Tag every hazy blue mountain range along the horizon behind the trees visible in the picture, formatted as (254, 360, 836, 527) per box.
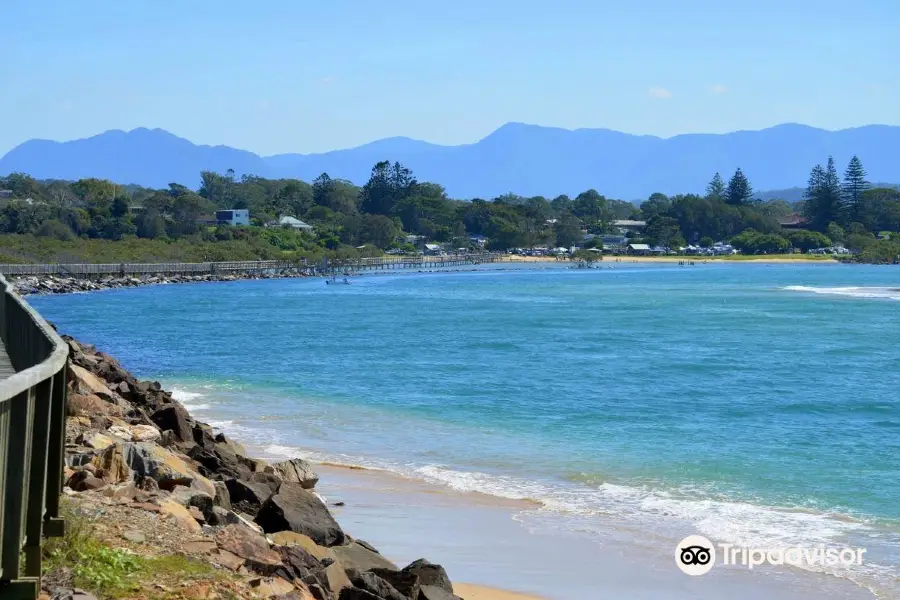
(0, 123, 900, 200)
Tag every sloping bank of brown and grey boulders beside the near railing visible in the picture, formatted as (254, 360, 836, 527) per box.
(53, 336, 468, 600)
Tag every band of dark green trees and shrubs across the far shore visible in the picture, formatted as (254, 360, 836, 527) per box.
(0, 157, 900, 262)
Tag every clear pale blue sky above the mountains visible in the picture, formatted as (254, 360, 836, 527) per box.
(0, 0, 900, 155)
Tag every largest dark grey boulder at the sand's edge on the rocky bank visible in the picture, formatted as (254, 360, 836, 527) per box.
(256, 483, 346, 547)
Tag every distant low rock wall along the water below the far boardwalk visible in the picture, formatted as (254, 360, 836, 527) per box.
(7, 269, 315, 296)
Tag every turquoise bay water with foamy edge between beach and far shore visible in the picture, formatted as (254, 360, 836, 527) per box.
(30, 263, 900, 597)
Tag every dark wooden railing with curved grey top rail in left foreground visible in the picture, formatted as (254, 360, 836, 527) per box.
(0, 276, 68, 600)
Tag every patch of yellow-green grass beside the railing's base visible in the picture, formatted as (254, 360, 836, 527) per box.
(43, 503, 230, 600)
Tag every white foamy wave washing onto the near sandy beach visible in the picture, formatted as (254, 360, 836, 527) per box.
(256, 445, 900, 590)
